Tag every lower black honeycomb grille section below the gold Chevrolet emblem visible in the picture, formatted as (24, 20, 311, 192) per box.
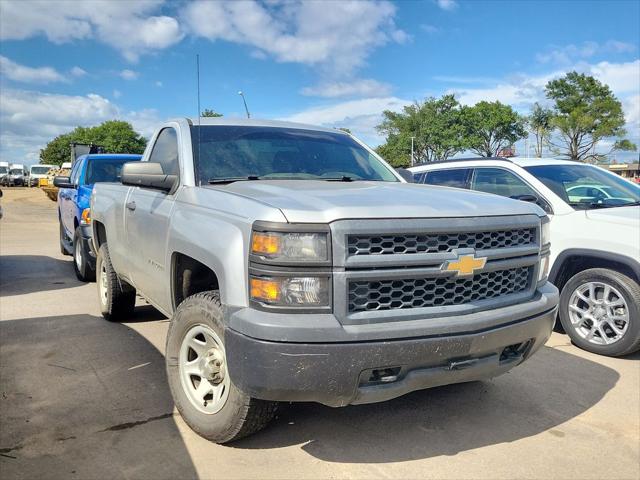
(349, 267, 532, 313)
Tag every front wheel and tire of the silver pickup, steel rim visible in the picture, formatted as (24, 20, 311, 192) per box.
(165, 291, 277, 444)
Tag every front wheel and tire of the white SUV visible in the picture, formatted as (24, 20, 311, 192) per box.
(560, 268, 640, 357)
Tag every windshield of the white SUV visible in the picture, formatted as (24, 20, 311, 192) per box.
(525, 164, 640, 210)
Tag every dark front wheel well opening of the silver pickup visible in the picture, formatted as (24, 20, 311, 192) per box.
(172, 253, 220, 308)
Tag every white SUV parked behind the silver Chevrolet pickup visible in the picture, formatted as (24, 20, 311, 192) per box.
(410, 158, 640, 356)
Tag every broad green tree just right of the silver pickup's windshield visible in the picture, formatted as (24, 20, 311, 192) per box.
(377, 95, 467, 166)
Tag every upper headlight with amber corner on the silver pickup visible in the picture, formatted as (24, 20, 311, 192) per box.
(251, 231, 329, 263)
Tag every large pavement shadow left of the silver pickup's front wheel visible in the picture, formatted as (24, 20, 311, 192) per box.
(0, 314, 197, 479)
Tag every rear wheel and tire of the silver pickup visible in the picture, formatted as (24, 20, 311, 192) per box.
(96, 243, 136, 322)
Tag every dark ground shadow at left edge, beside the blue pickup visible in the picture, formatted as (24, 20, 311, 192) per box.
(0, 255, 84, 297)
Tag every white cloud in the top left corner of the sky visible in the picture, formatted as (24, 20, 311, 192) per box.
(0, 0, 183, 61)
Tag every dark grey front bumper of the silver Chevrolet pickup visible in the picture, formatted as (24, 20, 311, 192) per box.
(225, 287, 558, 407)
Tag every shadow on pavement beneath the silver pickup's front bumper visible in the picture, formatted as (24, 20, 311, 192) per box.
(233, 347, 619, 463)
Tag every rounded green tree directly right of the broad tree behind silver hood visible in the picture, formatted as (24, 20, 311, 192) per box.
(462, 101, 527, 157)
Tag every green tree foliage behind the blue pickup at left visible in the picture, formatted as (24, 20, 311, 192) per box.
(40, 120, 147, 165)
